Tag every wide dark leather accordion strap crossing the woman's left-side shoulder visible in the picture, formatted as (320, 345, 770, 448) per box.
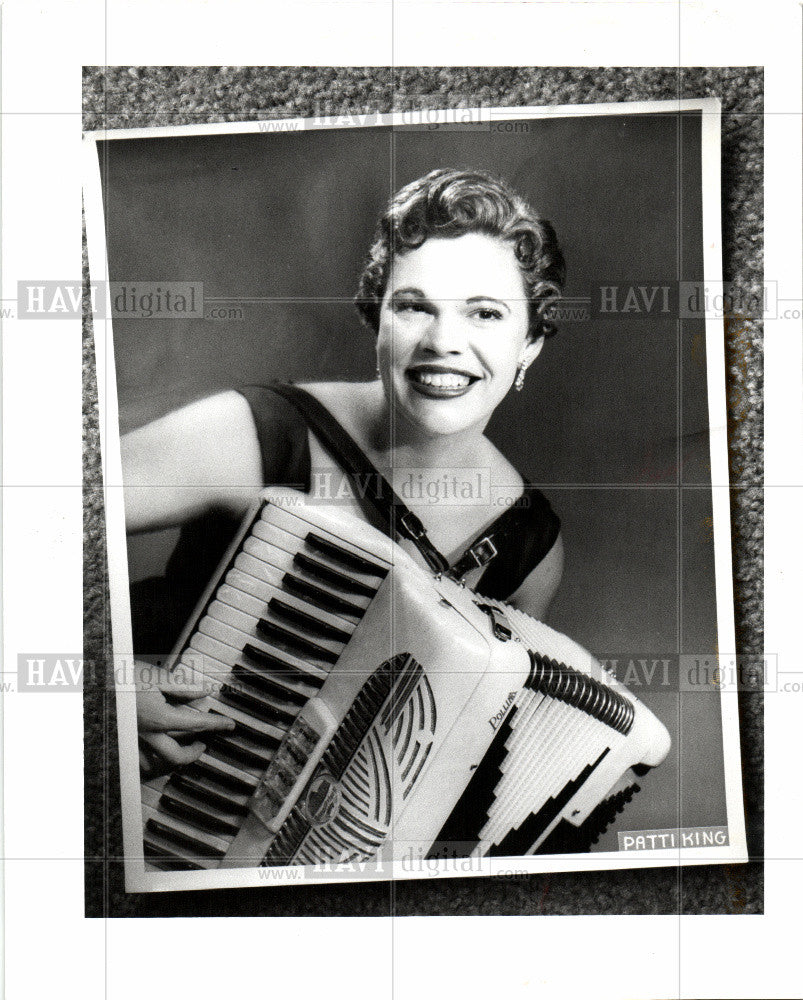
(272, 382, 449, 573)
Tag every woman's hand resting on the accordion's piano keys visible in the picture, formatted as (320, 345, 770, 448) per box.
(134, 663, 234, 777)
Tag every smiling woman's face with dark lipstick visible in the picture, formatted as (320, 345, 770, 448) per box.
(377, 233, 543, 437)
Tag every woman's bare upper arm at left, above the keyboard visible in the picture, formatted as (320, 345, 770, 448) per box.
(121, 391, 262, 532)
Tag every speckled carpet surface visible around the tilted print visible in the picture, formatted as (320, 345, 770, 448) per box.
(83, 67, 763, 916)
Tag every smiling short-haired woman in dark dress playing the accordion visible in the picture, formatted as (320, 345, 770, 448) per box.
(122, 169, 564, 764)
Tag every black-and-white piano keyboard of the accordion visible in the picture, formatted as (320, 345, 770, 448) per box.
(143, 504, 398, 869)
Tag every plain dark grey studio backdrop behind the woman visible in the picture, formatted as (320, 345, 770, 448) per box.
(100, 107, 725, 849)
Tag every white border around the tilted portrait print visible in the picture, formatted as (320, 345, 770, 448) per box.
(84, 98, 748, 892)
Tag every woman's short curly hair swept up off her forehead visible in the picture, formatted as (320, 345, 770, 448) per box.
(354, 168, 566, 340)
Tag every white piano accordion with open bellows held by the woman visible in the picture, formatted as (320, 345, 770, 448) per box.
(142, 489, 670, 870)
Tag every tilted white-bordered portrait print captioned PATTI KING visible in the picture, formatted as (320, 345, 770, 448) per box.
(85, 98, 747, 904)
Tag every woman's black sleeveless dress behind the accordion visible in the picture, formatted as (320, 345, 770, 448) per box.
(131, 385, 560, 658)
